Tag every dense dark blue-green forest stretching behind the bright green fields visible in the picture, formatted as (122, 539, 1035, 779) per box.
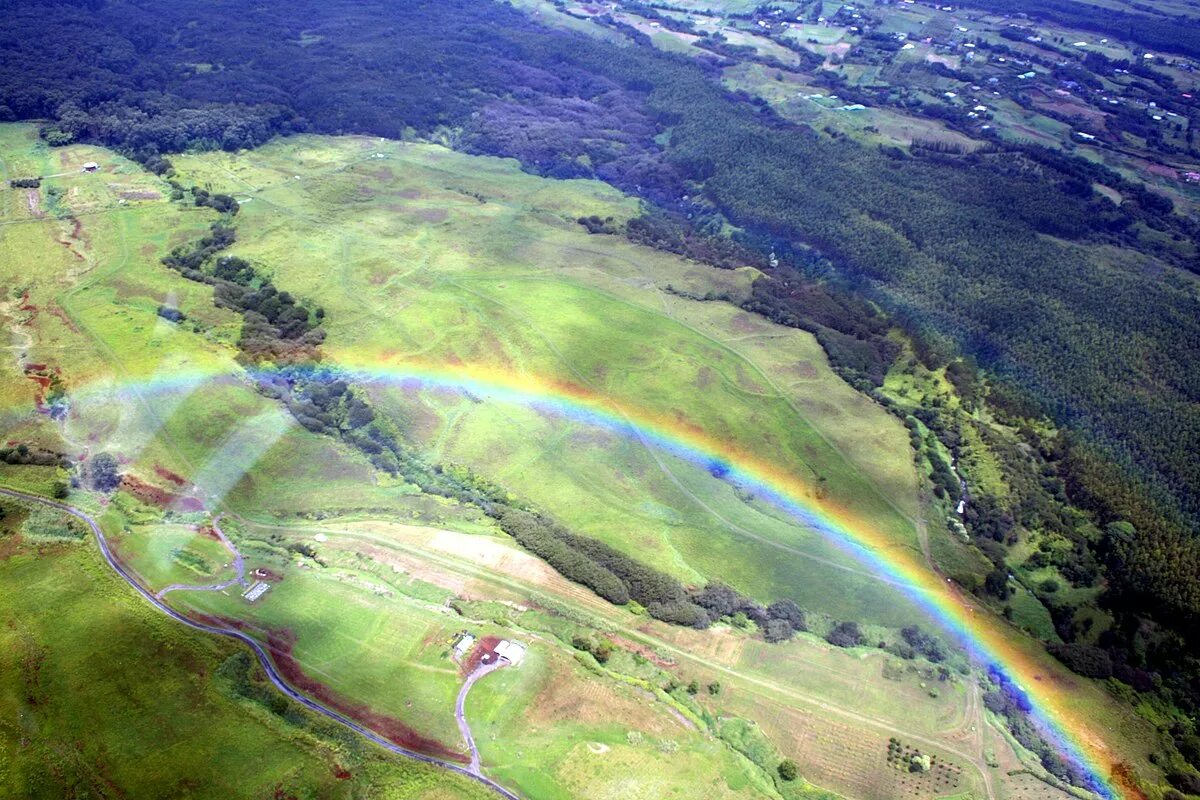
(7, 0, 1200, 762)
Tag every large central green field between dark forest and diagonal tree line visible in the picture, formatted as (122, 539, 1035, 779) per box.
(171, 138, 917, 624)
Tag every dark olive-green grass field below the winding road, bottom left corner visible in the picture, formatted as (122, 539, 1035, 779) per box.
(0, 503, 491, 800)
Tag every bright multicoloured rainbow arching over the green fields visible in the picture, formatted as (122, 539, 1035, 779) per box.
(42, 353, 1140, 800)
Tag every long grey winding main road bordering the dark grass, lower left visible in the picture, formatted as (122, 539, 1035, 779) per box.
(0, 487, 521, 800)
